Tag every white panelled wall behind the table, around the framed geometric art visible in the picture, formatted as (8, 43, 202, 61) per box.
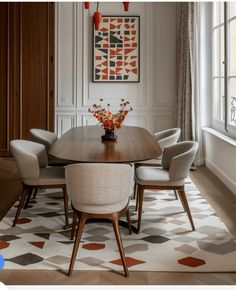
(55, 2, 176, 136)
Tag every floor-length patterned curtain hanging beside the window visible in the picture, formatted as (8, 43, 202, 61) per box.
(176, 2, 203, 165)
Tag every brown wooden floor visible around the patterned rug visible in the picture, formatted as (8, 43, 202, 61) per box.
(0, 158, 236, 285)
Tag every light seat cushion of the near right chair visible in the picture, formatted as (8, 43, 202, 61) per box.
(135, 167, 184, 186)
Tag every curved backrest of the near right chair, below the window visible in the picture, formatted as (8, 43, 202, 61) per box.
(162, 141, 198, 180)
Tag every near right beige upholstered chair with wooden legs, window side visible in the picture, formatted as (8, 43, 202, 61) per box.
(135, 141, 198, 231)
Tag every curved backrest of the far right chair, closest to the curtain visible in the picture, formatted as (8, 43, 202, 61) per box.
(153, 128, 181, 150)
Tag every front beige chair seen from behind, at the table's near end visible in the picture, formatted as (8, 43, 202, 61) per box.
(66, 163, 134, 276)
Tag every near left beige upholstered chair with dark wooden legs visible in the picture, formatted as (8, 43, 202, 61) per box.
(10, 140, 68, 226)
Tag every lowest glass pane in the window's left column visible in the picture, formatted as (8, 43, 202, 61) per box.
(213, 78, 225, 121)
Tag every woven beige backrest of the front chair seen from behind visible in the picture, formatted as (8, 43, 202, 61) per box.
(65, 163, 134, 205)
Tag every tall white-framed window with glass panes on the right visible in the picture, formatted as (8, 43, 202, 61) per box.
(213, 2, 236, 137)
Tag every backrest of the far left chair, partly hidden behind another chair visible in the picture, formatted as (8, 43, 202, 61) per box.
(30, 129, 58, 153)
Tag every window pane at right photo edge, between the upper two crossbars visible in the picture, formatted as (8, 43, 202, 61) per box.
(229, 19, 236, 75)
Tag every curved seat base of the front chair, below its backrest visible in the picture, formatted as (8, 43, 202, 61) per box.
(72, 198, 129, 214)
